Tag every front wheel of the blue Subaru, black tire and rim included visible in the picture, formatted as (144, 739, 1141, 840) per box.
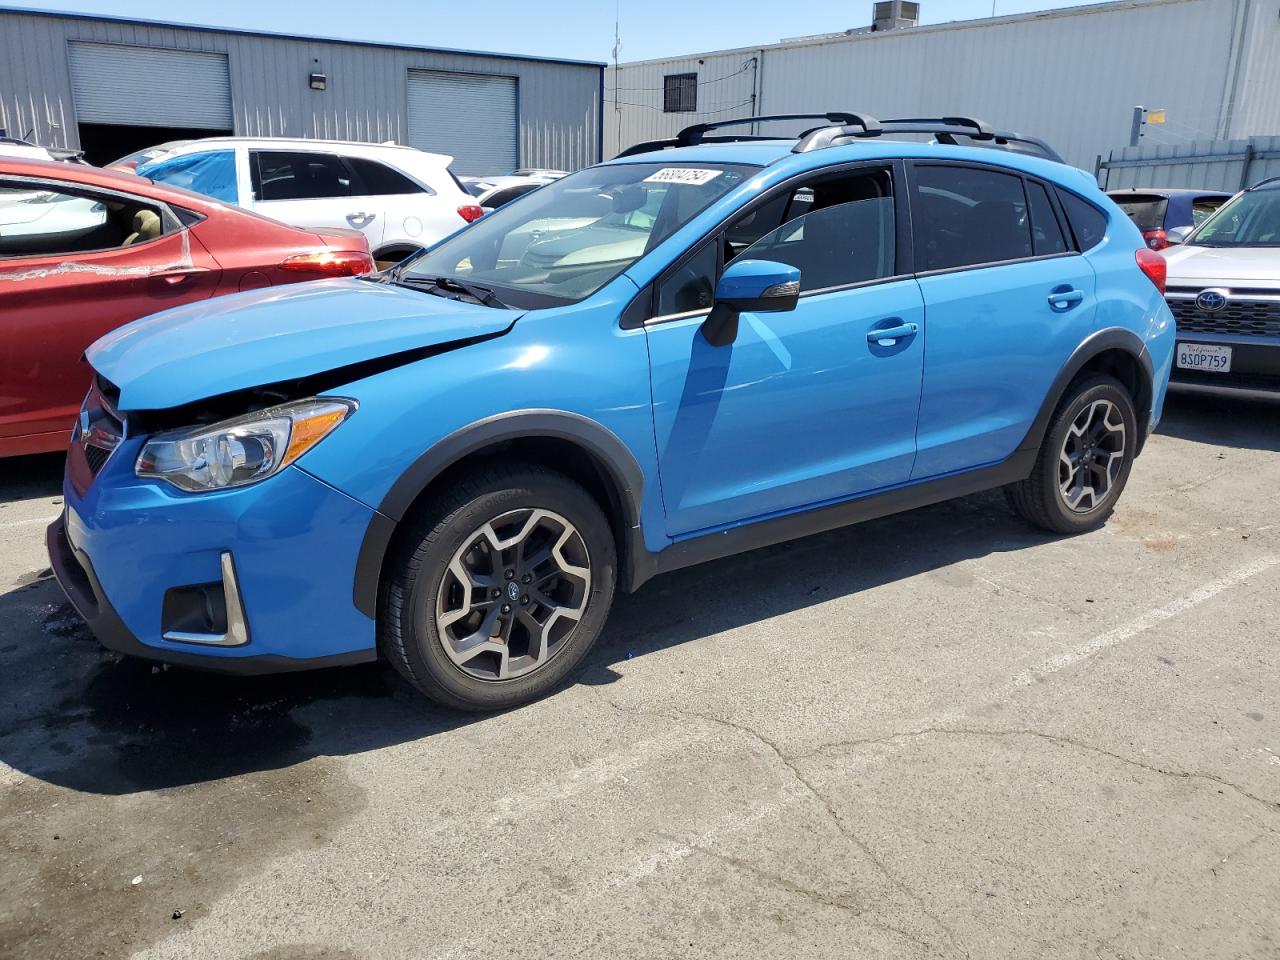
(379, 463, 617, 710)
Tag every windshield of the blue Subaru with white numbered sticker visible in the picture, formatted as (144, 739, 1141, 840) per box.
(393, 163, 756, 308)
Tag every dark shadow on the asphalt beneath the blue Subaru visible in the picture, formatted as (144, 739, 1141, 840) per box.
(0, 493, 1048, 795)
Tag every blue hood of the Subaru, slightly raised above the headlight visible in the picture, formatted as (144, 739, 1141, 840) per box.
(86, 279, 520, 410)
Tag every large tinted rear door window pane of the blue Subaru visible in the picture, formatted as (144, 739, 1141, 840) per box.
(911, 165, 1032, 270)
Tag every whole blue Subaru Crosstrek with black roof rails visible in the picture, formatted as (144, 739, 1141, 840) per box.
(47, 114, 1175, 709)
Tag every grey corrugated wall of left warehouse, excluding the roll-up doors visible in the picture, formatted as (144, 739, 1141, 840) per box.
(0, 10, 600, 170)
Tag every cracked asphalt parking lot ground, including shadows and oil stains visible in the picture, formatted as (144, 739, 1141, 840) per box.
(0, 394, 1280, 960)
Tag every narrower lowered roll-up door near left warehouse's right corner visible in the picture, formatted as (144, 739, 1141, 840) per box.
(408, 70, 520, 175)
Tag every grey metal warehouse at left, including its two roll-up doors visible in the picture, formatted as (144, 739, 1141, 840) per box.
(0, 10, 604, 174)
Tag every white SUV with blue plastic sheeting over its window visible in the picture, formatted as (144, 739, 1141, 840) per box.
(136, 137, 483, 264)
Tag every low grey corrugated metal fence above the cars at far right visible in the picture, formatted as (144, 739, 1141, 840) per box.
(1098, 137, 1280, 193)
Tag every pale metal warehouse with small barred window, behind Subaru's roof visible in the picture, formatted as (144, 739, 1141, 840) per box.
(605, 0, 1280, 169)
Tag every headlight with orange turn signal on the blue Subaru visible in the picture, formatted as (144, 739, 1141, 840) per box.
(134, 397, 356, 492)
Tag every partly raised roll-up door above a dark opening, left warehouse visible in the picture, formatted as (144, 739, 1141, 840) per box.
(68, 41, 233, 131)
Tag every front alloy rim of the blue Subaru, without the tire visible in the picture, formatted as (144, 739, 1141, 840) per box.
(435, 508, 591, 681)
